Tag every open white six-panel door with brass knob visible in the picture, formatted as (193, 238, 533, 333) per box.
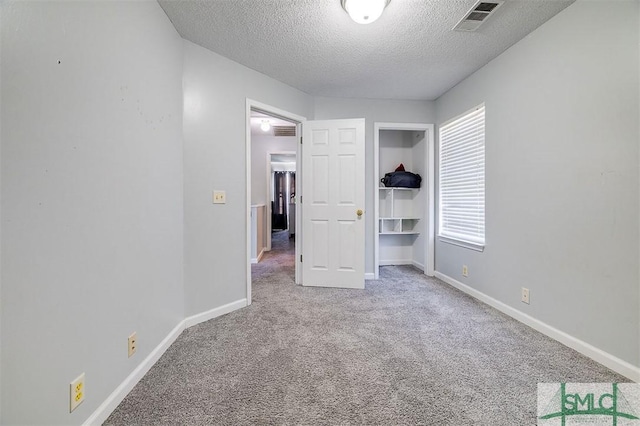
(302, 118, 365, 288)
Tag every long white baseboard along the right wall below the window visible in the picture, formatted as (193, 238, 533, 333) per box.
(435, 271, 640, 382)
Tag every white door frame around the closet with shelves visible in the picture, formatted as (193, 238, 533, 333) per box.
(373, 122, 436, 279)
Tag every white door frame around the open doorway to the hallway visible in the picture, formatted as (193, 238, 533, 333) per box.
(245, 98, 307, 305)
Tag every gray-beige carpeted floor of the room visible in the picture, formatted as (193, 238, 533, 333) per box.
(105, 234, 628, 426)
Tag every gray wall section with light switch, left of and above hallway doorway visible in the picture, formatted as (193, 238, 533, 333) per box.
(183, 41, 313, 315)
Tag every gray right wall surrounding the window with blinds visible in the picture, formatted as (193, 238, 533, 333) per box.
(436, 1, 640, 365)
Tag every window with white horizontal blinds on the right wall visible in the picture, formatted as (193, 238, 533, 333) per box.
(438, 104, 485, 250)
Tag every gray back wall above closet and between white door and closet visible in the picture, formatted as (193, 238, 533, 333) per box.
(314, 97, 436, 274)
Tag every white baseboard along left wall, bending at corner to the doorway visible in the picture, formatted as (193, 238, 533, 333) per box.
(83, 299, 247, 426)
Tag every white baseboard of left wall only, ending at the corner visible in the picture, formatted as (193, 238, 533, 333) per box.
(84, 320, 185, 425)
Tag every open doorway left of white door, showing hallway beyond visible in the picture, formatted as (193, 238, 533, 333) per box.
(246, 99, 305, 304)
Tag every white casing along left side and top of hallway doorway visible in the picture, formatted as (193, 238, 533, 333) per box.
(245, 98, 307, 305)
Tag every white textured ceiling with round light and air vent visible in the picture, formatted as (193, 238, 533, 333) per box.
(159, 0, 574, 100)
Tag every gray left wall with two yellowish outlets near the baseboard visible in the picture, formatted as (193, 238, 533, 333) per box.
(1, 1, 184, 425)
